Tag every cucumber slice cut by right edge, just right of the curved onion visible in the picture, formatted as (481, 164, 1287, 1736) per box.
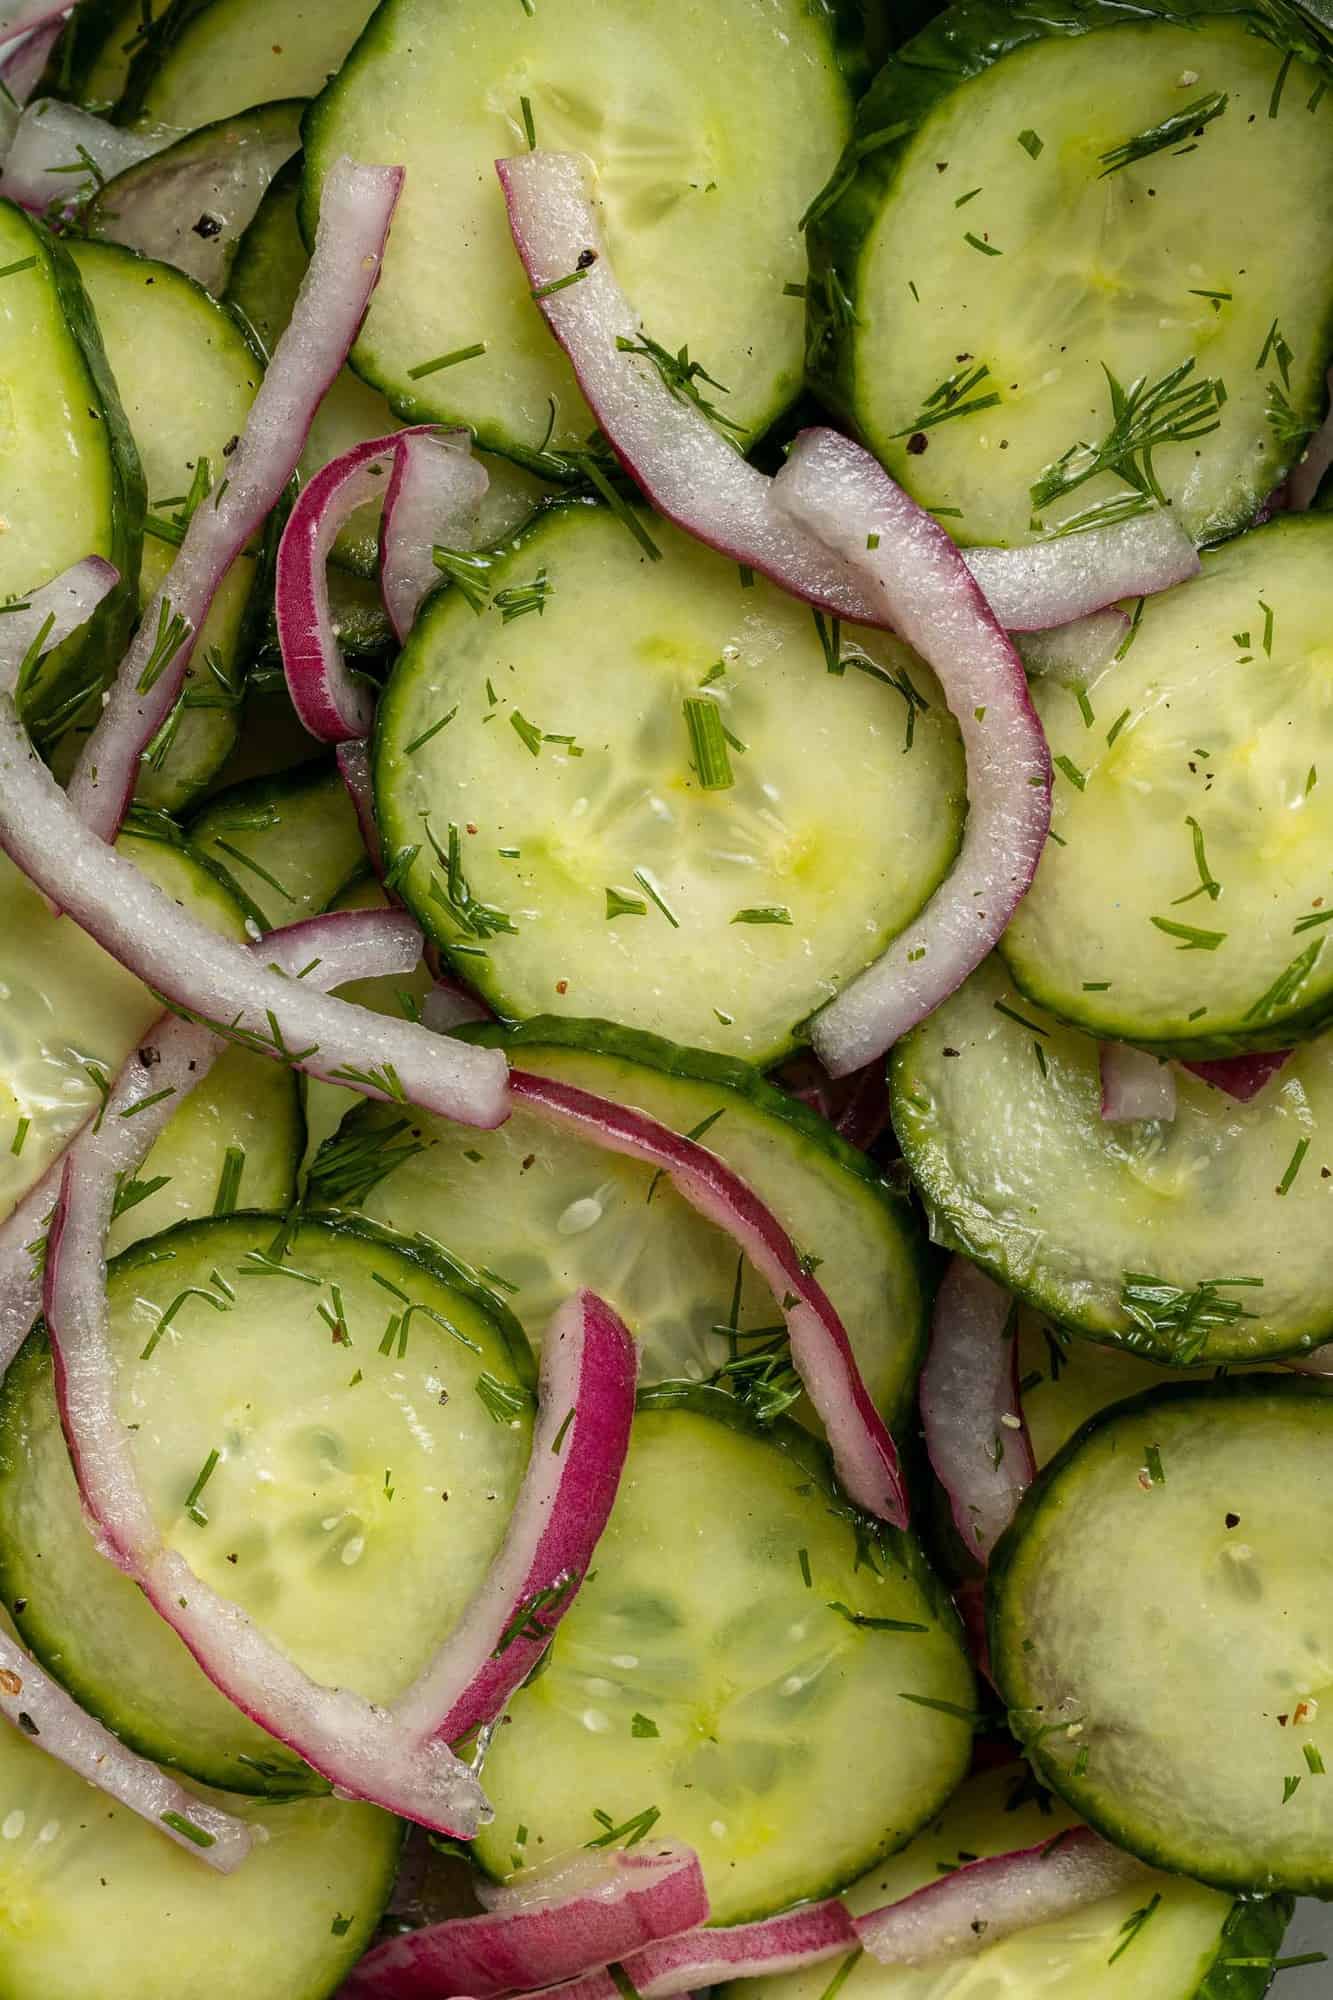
(1001, 514, 1333, 1056)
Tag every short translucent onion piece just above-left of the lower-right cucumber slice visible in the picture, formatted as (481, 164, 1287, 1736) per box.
(921, 1256, 1037, 1566)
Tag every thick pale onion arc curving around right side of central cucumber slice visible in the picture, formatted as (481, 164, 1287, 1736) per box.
(768, 428, 1051, 1076)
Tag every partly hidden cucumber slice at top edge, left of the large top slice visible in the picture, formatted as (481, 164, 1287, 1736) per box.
(120, 0, 374, 132)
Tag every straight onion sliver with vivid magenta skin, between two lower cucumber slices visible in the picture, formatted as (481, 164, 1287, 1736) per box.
(394, 1292, 638, 1744)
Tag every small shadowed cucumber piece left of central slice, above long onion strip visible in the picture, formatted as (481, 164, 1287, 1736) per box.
(190, 762, 366, 930)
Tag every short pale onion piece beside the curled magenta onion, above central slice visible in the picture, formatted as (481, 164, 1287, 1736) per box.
(380, 430, 490, 644)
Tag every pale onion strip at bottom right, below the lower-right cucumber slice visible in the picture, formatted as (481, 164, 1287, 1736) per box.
(855, 1826, 1147, 1966)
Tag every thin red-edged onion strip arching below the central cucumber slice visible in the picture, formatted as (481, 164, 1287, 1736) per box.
(510, 1070, 907, 1528)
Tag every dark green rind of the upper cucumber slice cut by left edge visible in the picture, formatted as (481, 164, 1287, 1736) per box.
(2, 202, 148, 748)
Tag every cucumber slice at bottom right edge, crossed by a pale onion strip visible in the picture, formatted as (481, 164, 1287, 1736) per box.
(719, 1766, 1291, 2000)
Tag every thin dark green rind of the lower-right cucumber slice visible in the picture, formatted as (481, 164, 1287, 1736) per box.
(987, 1374, 1333, 1888)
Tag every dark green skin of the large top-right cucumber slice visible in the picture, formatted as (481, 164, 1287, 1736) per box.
(805, 0, 1333, 544)
